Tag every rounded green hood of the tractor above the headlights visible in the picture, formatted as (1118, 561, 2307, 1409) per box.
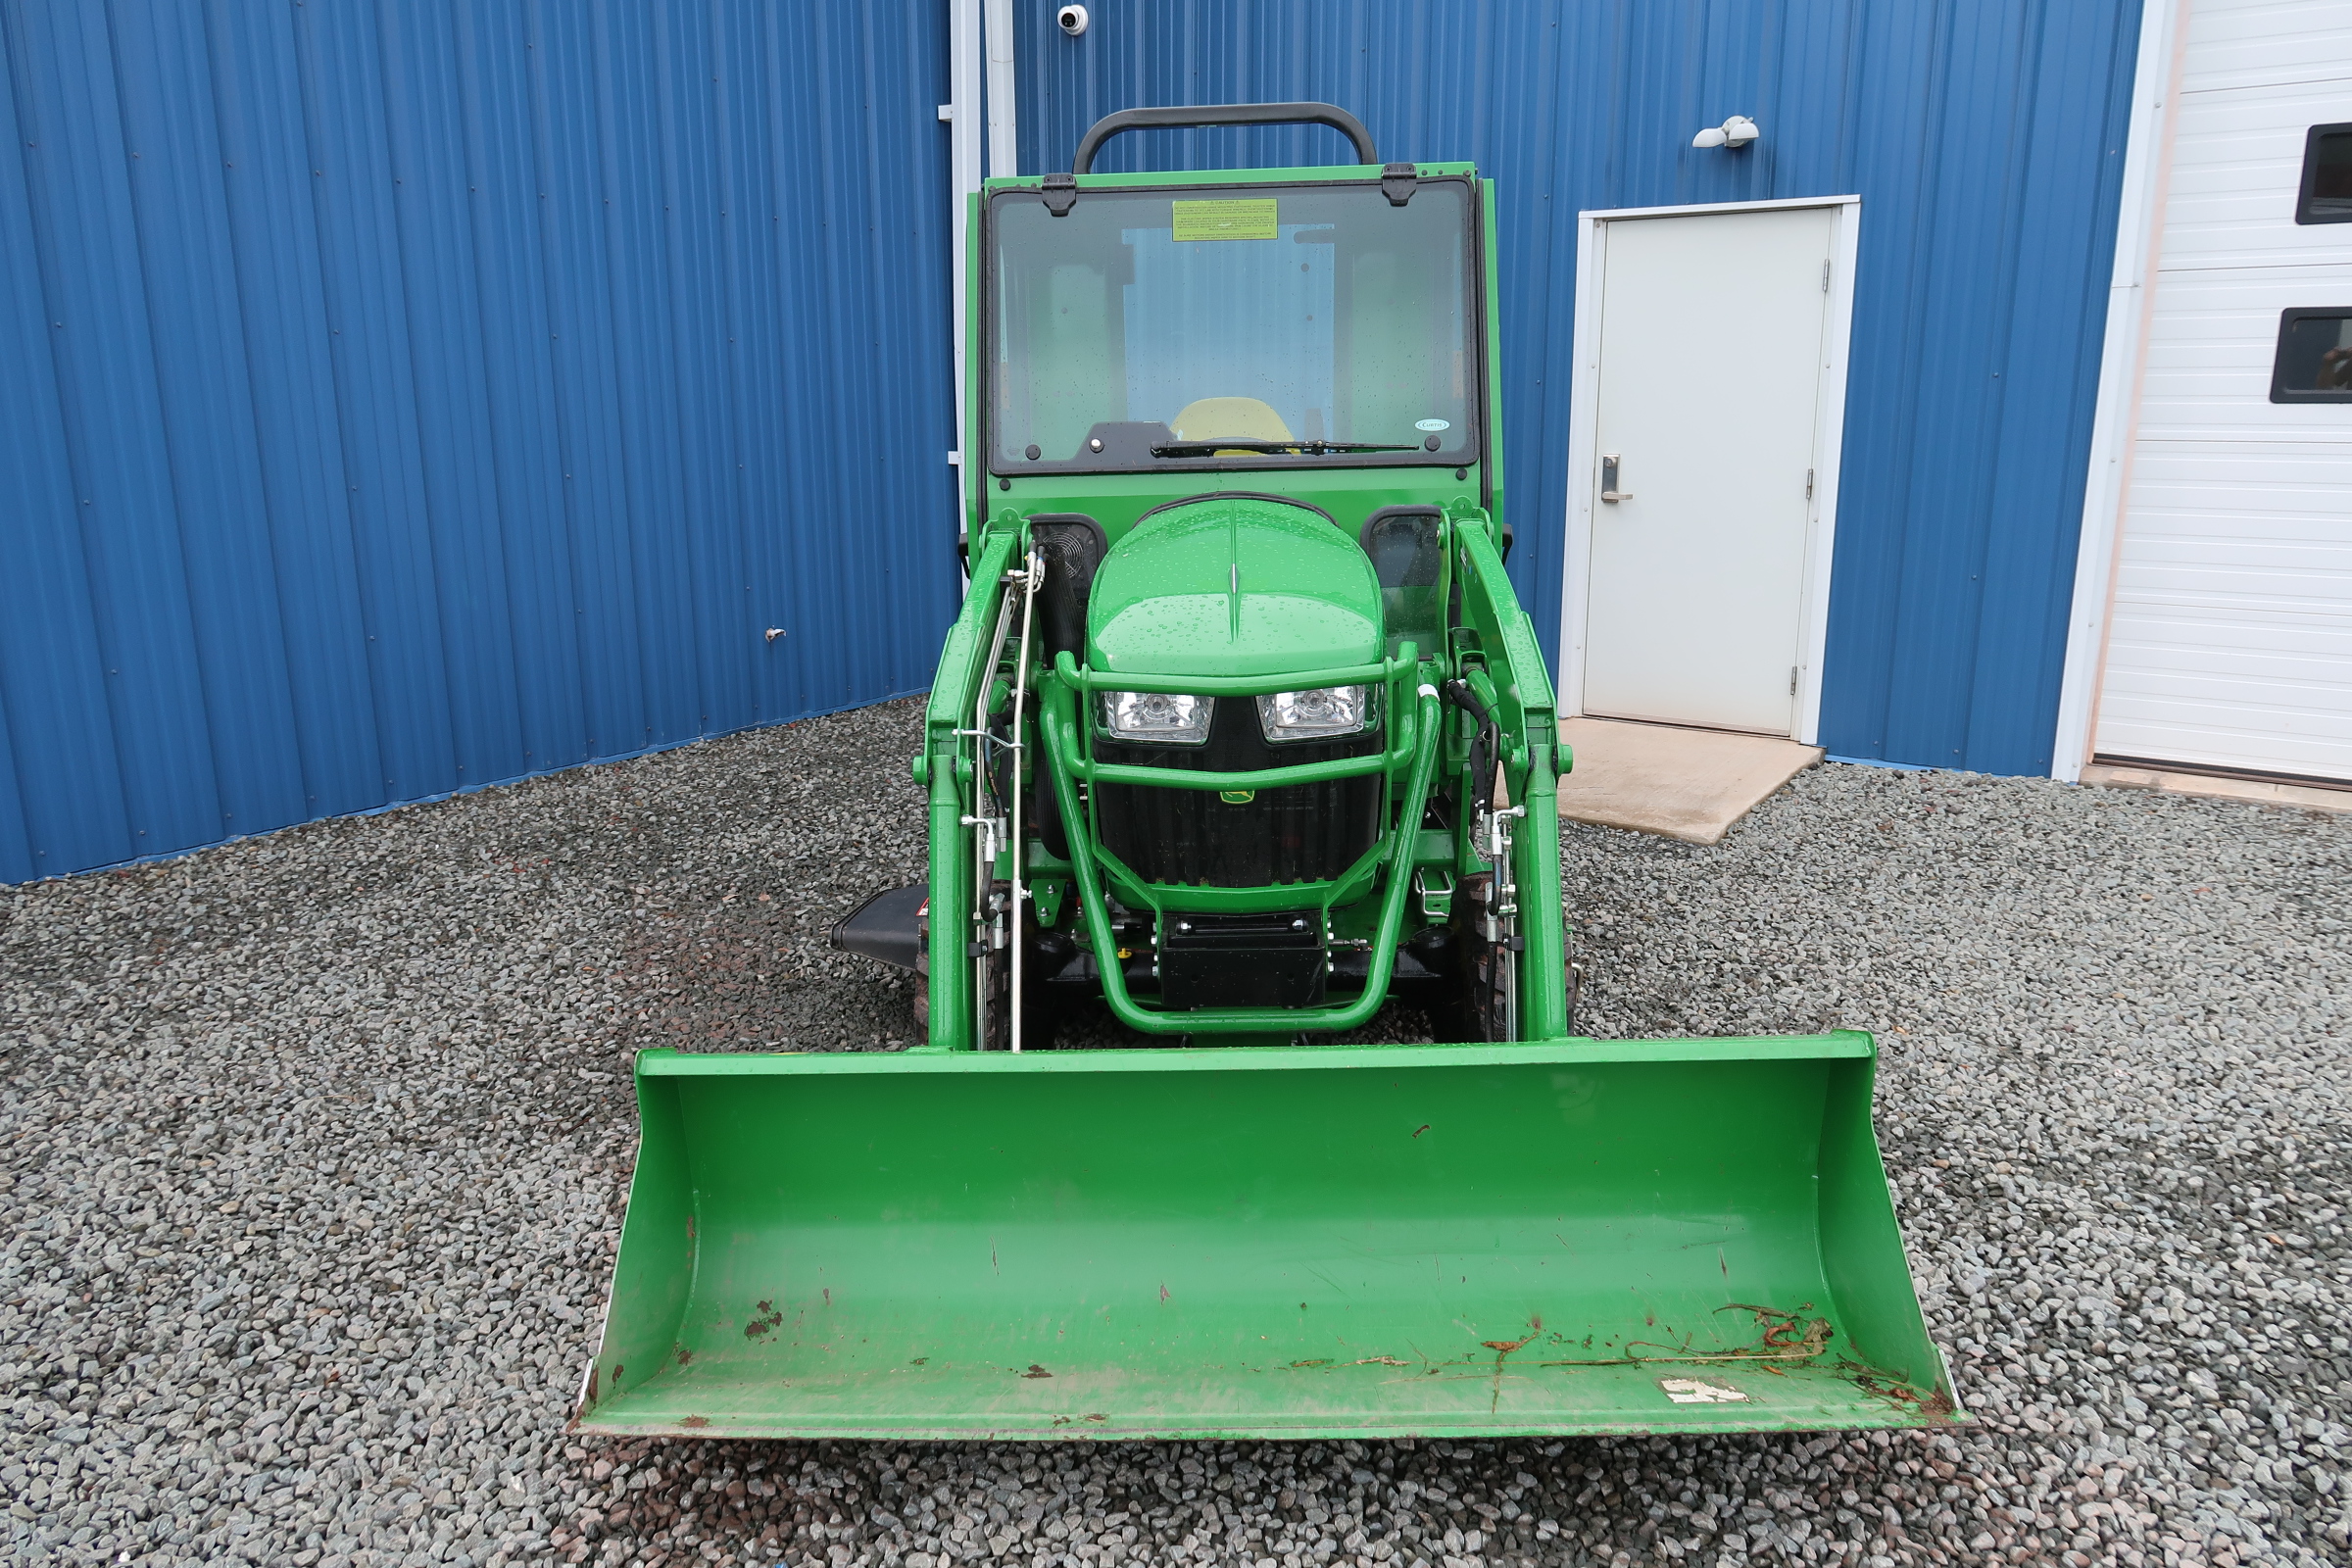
(1087, 496, 1383, 674)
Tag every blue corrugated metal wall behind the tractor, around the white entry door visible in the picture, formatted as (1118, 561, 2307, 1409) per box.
(1018, 0, 2138, 773)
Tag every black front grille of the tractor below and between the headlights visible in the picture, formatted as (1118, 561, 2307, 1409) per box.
(1094, 696, 1388, 886)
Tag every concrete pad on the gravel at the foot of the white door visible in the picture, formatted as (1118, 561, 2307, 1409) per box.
(1559, 719, 1821, 844)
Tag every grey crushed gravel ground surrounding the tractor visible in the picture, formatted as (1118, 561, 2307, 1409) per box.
(0, 703, 2352, 1568)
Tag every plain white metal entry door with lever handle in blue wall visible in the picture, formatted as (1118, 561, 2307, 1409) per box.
(1583, 207, 1835, 736)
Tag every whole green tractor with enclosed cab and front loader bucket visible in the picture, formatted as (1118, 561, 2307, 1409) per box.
(576, 104, 1962, 1439)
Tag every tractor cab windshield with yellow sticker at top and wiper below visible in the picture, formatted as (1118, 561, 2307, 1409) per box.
(990, 178, 1477, 472)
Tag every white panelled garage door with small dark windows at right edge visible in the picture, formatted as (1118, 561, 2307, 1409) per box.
(2095, 0, 2352, 780)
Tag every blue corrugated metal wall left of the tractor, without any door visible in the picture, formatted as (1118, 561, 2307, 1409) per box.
(0, 0, 959, 882)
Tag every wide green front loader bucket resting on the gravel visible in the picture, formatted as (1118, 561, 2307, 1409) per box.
(578, 1034, 1962, 1439)
